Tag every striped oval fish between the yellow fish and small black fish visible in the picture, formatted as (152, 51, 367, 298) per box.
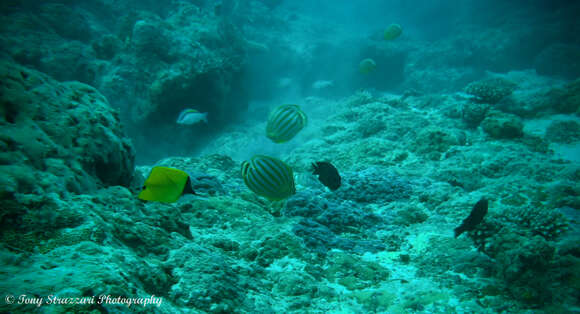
(242, 155, 296, 201)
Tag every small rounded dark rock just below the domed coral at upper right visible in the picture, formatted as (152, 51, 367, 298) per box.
(481, 111, 524, 139)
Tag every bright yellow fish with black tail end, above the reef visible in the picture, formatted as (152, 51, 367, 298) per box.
(138, 167, 195, 203)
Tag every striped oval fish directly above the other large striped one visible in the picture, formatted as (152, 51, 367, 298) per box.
(266, 105, 308, 143)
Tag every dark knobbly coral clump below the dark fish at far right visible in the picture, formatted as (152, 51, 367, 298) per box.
(468, 207, 567, 304)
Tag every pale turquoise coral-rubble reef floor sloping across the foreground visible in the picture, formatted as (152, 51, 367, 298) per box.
(0, 76, 579, 312)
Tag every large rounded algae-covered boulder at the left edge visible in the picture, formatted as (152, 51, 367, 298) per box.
(0, 62, 135, 197)
